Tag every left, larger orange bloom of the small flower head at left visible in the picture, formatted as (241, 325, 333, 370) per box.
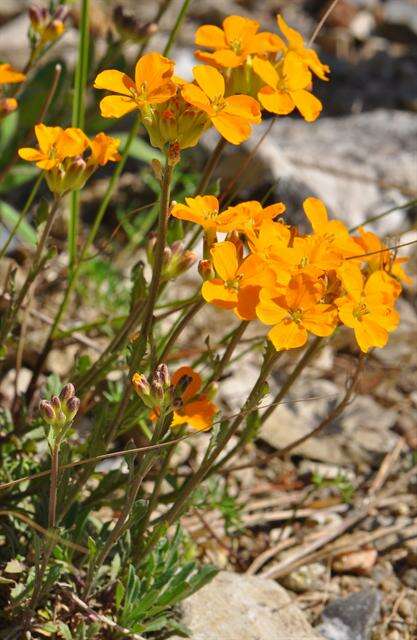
(19, 124, 89, 171)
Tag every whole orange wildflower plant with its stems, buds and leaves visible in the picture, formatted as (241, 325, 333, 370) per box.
(0, 0, 409, 638)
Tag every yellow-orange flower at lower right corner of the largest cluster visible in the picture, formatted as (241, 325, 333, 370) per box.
(335, 263, 399, 353)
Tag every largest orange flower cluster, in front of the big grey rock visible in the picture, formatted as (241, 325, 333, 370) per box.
(171, 196, 409, 352)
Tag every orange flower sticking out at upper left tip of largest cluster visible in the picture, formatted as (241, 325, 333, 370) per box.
(171, 196, 236, 232)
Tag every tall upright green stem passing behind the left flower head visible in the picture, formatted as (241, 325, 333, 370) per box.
(68, 0, 90, 280)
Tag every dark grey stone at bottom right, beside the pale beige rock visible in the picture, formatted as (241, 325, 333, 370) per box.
(318, 589, 381, 640)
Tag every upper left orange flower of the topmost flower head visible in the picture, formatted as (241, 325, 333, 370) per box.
(195, 16, 285, 68)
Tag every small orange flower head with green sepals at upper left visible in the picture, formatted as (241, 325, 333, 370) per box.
(19, 124, 120, 195)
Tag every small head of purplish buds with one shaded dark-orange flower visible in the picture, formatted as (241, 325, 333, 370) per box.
(132, 364, 218, 431)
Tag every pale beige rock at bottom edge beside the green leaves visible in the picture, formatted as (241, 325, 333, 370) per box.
(172, 571, 320, 640)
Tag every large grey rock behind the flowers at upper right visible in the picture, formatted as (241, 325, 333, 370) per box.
(234, 109, 417, 234)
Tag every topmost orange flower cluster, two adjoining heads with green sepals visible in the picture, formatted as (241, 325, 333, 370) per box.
(94, 16, 329, 149)
